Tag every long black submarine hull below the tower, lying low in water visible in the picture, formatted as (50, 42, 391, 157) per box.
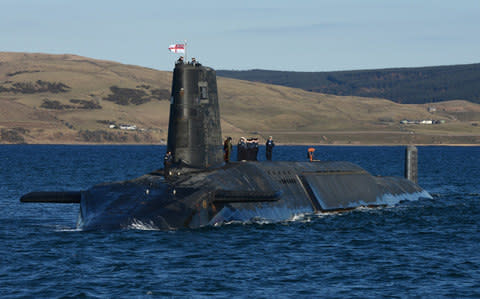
(78, 162, 430, 230)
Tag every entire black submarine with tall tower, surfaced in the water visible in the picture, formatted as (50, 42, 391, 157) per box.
(20, 61, 431, 230)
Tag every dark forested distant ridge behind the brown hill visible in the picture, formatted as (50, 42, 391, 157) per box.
(218, 64, 480, 104)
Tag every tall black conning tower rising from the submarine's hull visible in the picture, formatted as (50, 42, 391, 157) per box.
(167, 63, 223, 168)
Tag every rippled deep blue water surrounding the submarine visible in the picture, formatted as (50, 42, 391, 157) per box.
(0, 145, 480, 298)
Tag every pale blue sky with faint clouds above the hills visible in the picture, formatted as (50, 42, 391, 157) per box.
(0, 0, 480, 71)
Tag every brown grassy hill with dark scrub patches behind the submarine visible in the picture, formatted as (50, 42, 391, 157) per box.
(0, 53, 480, 144)
